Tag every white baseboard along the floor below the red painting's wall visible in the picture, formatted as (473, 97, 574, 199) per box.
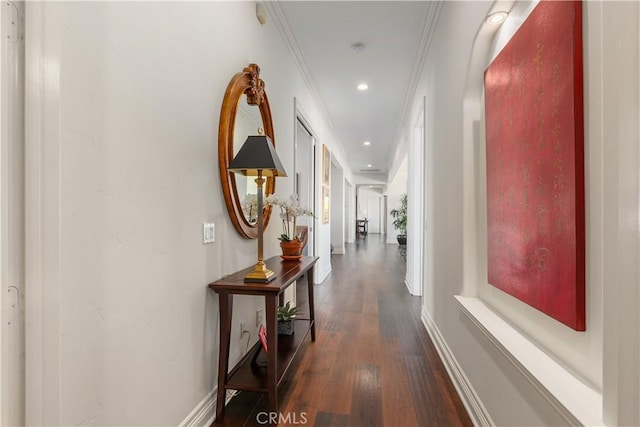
(421, 307, 495, 426)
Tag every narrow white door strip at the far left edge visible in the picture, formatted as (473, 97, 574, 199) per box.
(0, 1, 25, 426)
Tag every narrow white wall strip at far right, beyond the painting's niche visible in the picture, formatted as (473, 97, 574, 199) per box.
(600, 2, 640, 425)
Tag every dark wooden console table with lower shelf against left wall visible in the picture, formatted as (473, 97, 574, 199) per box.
(209, 256, 318, 422)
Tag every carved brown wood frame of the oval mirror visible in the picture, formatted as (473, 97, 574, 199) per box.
(218, 64, 276, 239)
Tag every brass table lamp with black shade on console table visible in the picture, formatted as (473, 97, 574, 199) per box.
(228, 135, 287, 283)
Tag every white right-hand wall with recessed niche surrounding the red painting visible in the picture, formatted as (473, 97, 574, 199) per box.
(405, 2, 640, 425)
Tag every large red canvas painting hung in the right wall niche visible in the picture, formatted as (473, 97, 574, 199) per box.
(485, 1, 585, 331)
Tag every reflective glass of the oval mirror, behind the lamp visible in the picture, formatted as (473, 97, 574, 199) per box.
(233, 95, 263, 224)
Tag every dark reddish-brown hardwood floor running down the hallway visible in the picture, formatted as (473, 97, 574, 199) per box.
(218, 234, 472, 427)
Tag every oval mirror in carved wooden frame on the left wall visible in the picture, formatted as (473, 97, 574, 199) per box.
(218, 64, 275, 239)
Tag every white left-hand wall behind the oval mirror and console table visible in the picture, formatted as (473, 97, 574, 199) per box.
(26, 2, 340, 425)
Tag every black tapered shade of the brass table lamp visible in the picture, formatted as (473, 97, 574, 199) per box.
(228, 135, 287, 176)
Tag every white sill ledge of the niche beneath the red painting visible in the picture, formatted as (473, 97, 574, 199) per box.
(455, 295, 604, 426)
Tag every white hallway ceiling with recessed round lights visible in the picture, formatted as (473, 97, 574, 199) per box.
(270, 1, 436, 182)
